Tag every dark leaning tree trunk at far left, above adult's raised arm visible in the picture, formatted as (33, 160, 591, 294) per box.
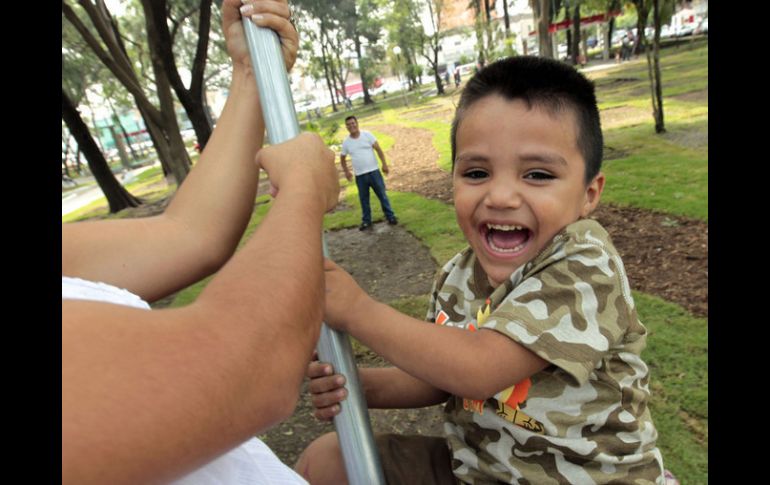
(62, 89, 141, 213)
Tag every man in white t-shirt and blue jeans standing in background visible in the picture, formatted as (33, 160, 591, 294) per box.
(340, 116, 398, 231)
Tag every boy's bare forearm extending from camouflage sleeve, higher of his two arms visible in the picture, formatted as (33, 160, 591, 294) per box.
(325, 260, 549, 399)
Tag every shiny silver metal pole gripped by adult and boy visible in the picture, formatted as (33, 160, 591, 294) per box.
(243, 19, 385, 485)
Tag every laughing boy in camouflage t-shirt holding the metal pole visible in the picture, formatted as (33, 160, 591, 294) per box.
(296, 57, 665, 484)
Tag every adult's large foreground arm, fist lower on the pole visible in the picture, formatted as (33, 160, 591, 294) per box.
(62, 134, 339, 484)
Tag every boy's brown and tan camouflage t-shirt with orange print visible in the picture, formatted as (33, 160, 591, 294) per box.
(428, 219, 663, 485)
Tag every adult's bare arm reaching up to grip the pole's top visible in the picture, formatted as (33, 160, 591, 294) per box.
(62, 0, 297, 301)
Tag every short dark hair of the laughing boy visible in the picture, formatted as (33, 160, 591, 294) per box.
(451, 56, 604, 184)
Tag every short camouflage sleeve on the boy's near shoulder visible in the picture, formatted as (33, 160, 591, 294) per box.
(483, 220, 645, 384)
